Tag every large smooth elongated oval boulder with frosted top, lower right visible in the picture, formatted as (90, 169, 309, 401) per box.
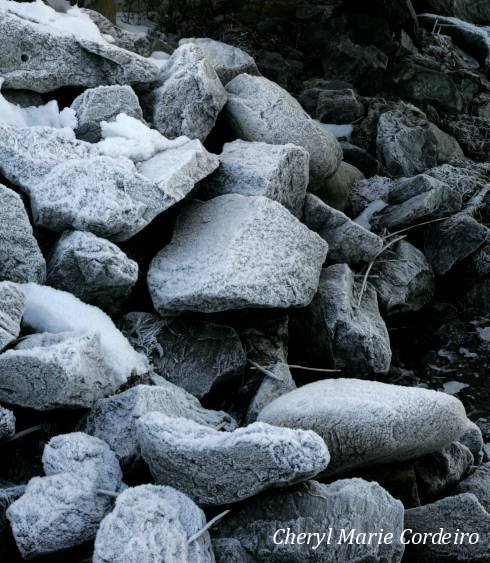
(259, 379, 467, 475)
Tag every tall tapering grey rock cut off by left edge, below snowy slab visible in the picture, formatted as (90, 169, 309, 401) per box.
(0, 185, 46, 284)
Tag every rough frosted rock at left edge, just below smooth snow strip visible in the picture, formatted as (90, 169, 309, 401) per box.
(0, 332, 118, 410)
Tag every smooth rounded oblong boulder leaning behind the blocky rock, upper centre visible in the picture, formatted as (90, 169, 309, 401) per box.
(226, 74, 342, 189)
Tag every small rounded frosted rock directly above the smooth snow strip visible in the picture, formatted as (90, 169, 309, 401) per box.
(47, 231, 138, 309)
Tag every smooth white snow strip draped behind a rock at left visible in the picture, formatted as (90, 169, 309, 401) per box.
(21, 283, 148, 384)
